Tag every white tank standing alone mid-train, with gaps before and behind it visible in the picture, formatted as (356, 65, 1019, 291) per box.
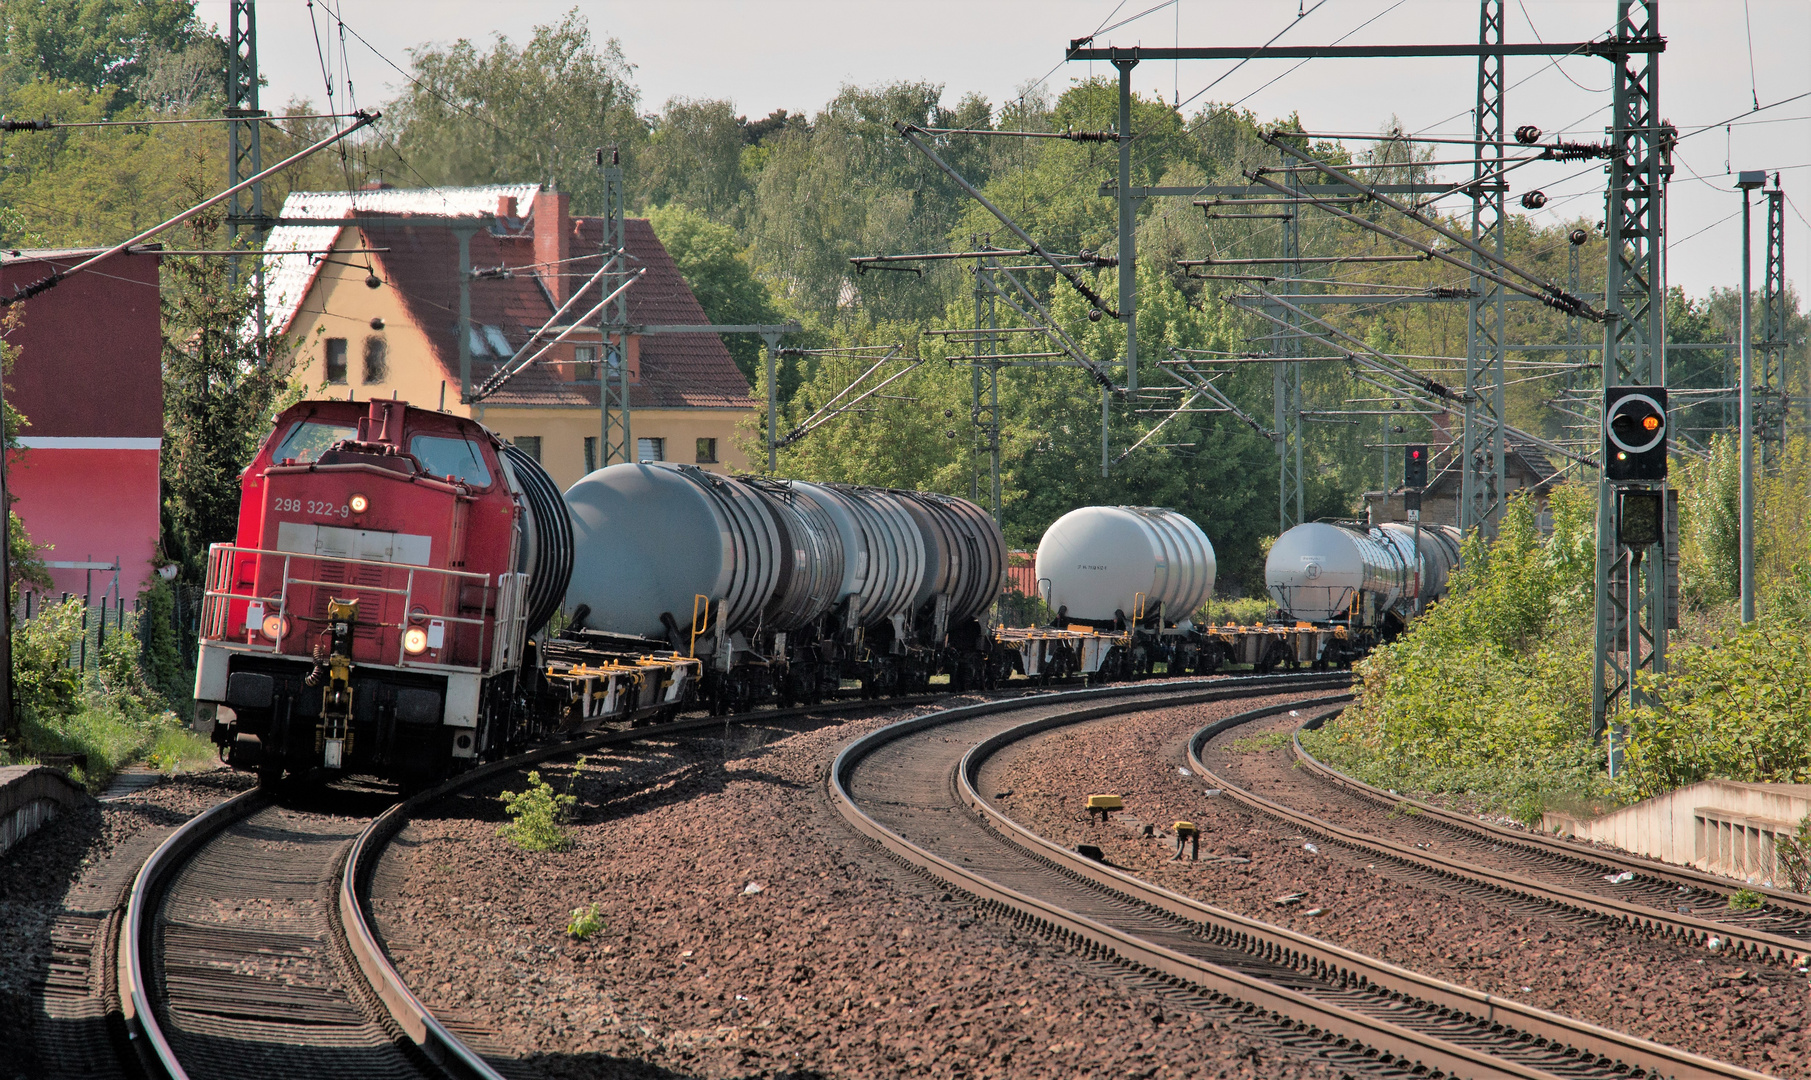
(1036, 506, 1215, 623)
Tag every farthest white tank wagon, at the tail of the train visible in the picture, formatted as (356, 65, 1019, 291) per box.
(1264, 522, 1460, 634)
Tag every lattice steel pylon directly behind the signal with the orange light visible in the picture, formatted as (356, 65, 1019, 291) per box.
(1592, 0, 1677, 753)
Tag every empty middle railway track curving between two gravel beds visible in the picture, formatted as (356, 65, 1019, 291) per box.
(829, 676, 1782, 1078)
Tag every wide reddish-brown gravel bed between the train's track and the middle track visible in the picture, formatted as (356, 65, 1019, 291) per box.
(373, 699, 1361, 1080)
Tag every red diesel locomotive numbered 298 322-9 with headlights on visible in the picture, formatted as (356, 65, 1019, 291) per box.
(196, 400, 586, 781)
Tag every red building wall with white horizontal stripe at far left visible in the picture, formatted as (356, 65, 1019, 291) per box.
(0, 252, 163, 598)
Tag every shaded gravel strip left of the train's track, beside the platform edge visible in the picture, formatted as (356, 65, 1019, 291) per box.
(0, 770, 255, 1078)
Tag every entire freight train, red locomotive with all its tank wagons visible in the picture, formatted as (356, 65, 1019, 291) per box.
(196, 400, 1458, 785)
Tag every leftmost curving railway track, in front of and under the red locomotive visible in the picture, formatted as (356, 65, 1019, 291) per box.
(109, 698, 977, 1080)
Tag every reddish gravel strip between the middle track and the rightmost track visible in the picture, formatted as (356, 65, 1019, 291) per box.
(980, 707, 1811, 1076)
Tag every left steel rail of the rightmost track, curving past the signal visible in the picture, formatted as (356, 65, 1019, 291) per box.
(1188, 710, 1807, 960)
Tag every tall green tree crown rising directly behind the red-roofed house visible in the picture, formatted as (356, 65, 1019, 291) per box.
(375, 7, 647, 214)
